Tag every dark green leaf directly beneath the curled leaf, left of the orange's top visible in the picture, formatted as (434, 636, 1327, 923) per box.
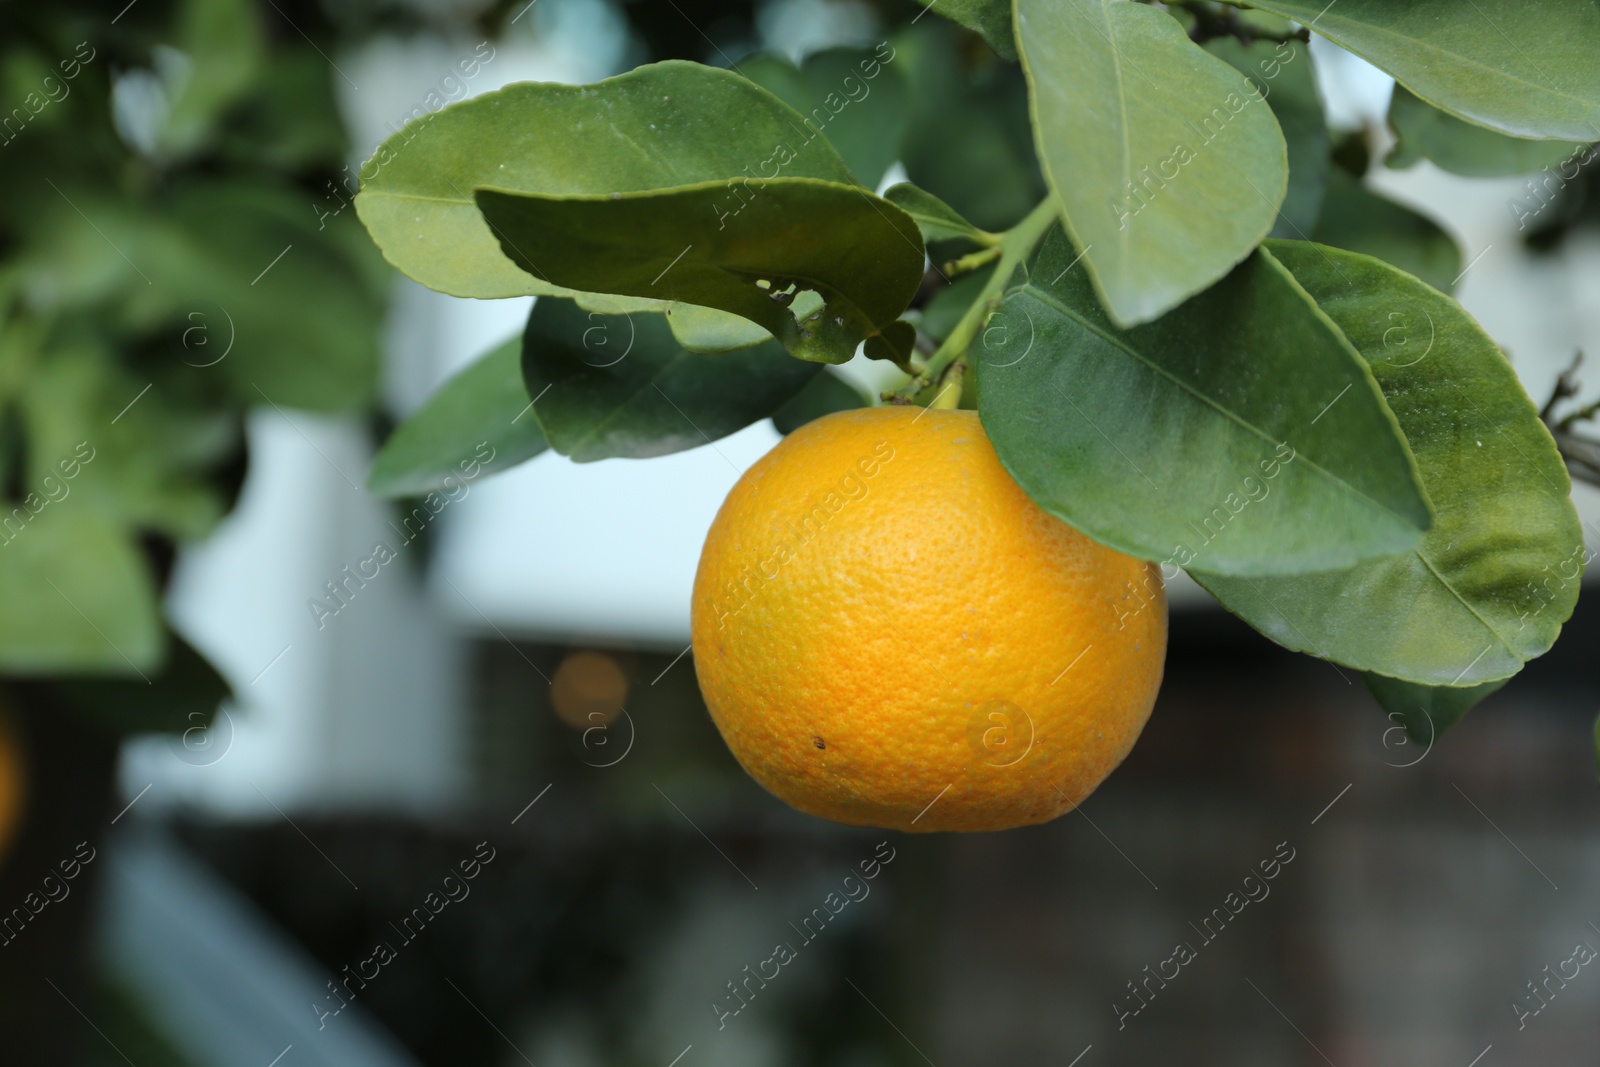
(522, 298, 822, 462)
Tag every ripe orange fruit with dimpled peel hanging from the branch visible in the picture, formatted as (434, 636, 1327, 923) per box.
(693, 406, 1166, 830)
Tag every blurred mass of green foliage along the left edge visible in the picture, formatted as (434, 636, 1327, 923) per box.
(0, 0, 389, 716)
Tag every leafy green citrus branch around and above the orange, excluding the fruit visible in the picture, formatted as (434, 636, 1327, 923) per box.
(355, 0, 1600, 819)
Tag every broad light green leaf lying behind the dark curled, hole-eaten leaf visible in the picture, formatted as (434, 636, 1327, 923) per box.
(355, 61, 854, 298)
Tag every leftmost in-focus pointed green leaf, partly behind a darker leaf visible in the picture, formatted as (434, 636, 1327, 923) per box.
(366, 338, 549, 496)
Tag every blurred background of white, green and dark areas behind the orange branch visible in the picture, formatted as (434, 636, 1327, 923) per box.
(0, 0, 1600, 1067)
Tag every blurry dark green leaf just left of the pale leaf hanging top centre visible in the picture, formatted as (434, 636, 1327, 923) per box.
(894, 19, 1046, 232)
